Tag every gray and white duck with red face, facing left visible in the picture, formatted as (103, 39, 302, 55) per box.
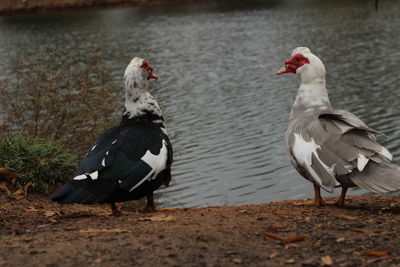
(277, 47, 400, 206)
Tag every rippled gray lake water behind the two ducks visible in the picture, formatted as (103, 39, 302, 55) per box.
(0, 0, 400, 207)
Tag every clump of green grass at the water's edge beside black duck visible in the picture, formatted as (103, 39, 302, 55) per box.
(0, 136, 78, 194)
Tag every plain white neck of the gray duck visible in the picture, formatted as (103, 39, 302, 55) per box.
(290, 75, 331, 117)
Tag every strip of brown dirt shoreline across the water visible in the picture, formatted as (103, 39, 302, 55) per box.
(0, 0, 216, 16)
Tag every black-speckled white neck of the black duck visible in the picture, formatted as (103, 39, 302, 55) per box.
(121, 88, 165, 128)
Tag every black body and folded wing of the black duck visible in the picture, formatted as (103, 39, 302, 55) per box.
(51, 124, 172, 204)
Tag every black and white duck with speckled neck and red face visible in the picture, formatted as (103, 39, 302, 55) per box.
(51, 57, 173, 215)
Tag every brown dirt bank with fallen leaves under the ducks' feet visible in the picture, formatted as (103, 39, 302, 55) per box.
(0, 195, 400, 266)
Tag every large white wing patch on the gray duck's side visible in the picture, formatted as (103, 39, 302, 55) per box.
(292, 134, 340, 186)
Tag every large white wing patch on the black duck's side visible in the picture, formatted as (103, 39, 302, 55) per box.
(129, 140, 168, 191)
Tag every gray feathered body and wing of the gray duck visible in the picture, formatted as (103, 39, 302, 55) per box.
(287, 110, 400, 192)
